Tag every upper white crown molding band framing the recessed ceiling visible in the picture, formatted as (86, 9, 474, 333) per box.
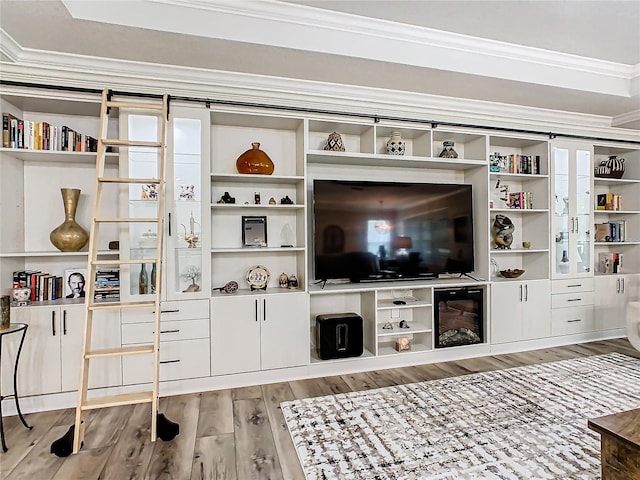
(58, 0, 640, 97)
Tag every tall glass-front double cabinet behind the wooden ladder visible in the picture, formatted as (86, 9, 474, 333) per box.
(120, 107, 210, 300)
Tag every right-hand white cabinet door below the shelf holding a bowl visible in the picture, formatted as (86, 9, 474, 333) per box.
(522, 280, 551, 340)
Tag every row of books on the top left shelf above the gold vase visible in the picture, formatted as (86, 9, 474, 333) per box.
(2, 113, 98, 152)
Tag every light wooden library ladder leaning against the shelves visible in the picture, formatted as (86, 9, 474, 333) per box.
(73, 89, 169, 453)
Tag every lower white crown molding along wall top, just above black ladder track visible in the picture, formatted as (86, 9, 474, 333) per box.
(0, 45, 624, 135)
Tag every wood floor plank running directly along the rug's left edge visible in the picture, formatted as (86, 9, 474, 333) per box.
(262, 382, 304, 480)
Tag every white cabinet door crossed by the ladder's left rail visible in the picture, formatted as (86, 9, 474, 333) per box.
(60, 305, 122, 392)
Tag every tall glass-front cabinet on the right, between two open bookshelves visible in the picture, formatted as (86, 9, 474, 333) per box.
(551, 142, 593, 278)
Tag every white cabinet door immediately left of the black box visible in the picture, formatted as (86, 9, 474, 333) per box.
(260, 293, 309, 370)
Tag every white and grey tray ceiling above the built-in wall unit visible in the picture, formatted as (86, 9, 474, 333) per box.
(0, 0, 640, 128)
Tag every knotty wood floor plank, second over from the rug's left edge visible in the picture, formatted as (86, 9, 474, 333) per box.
(233, 398, 283, 480)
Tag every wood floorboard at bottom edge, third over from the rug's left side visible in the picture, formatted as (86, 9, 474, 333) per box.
(191, 433, 238, 480)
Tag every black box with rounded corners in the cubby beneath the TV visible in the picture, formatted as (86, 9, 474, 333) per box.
(316, 313, 363, 360)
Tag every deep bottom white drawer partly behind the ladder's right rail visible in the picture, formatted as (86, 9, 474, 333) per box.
(122, 339, 211, 385)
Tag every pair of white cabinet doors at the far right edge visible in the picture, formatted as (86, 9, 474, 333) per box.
(595, 275, 640, 330)
